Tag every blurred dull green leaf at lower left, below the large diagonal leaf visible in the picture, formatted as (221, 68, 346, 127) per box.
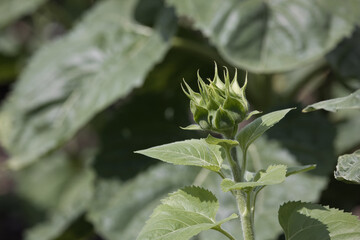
(17, 153, 95, 240)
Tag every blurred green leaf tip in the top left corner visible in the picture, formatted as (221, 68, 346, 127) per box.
(0, 0, 46, 29)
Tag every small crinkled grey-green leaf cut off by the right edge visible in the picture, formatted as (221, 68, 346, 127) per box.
(334, 150, 360, 184)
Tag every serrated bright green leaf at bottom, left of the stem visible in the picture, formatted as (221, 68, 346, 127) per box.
(137, 187, 237, 240)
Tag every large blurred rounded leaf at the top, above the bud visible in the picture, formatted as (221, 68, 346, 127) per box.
(167, 0, 354, 72)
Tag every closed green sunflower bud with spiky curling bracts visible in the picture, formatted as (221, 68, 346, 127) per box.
(183, 64, 257, 136)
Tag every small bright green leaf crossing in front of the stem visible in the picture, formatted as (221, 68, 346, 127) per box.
(221, 165, 286, 192)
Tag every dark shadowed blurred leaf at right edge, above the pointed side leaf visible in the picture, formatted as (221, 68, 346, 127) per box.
(326, 28, 360, 79)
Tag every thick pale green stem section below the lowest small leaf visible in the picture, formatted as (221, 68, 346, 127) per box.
(236, 191, 255, 240)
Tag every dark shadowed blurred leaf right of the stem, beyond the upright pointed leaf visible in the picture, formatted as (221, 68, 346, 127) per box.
(267, 111, 336, 176)
